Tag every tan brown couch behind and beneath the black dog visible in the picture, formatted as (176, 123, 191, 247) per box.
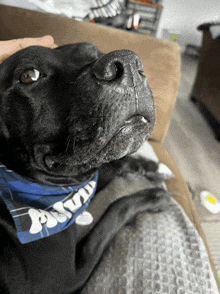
(0, 5, 220, 289)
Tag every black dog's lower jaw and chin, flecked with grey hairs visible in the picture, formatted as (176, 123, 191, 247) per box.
(44, 114, 154, 175)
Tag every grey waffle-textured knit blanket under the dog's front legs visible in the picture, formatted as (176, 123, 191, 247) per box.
(80, 141, 219, 294)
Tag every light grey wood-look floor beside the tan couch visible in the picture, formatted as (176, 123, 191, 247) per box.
(165, 55, 220, 277)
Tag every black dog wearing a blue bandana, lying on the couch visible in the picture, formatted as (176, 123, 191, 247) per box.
(0, 43, 169, 294)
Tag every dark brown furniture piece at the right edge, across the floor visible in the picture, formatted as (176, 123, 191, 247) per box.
(191, 23, 220, 141)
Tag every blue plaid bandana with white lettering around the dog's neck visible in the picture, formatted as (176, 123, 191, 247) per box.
(0, 163, 98, 244)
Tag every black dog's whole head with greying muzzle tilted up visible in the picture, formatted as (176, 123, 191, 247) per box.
(0, 43, 155, 185)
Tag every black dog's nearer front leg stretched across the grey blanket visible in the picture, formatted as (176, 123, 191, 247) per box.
(73, 188, 171, 293)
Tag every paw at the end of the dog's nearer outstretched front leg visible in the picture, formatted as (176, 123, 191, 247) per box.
(145, 188, 172, 212)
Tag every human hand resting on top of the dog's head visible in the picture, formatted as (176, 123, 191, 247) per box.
(0, 36, 57, 64)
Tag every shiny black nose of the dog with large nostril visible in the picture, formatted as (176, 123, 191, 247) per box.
(93, 50, 144, 81)
